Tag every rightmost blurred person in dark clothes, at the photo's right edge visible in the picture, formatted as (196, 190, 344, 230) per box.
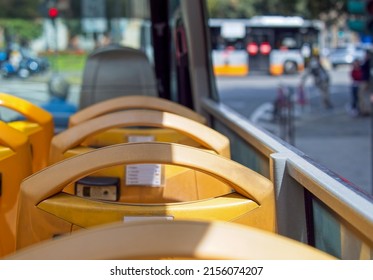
(358, 51, 370, 116)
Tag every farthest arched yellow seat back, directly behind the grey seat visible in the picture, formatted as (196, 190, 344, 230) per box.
(69, 95, 206, 147)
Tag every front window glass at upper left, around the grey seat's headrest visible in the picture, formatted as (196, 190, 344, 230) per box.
(0, 0, 154, 114)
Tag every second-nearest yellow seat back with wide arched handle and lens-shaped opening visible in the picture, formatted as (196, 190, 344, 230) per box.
(17, 142, 275, 249)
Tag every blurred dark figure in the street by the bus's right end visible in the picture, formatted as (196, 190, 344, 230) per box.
(301, 50, 333, 109)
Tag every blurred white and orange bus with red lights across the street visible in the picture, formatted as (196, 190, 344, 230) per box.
(209, 16, 324, 75)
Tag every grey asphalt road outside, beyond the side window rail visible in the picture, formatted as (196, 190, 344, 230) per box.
(217, 67, 373, 194)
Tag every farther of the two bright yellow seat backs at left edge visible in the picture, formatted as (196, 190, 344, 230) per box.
(0, 93, 54, 172)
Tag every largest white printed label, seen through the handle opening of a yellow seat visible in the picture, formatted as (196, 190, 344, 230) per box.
(126, 164, 162, 187)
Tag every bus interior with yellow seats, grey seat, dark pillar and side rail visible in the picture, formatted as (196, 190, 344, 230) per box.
(0, 0, 373, 260)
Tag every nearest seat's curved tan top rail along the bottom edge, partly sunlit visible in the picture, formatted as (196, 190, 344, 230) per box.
(6, 221, 335, 260)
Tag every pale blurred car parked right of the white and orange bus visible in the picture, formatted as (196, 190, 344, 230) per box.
(327, 46, 365, 68)
